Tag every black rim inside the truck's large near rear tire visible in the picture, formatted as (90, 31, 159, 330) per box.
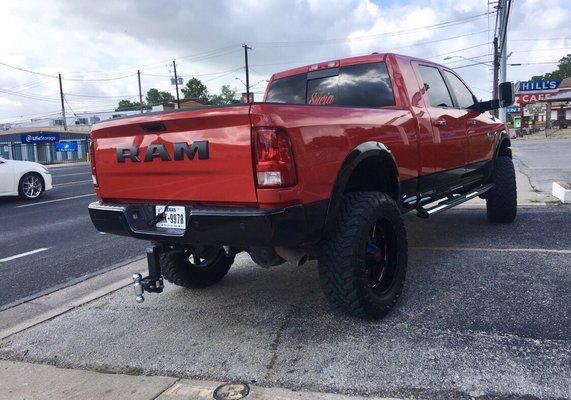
(363, 219, 397, 295)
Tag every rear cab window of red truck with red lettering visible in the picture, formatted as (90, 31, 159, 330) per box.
(266, 62, 395, 107)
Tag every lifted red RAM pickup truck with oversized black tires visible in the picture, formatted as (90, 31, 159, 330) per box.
(89, 54, 516, 318)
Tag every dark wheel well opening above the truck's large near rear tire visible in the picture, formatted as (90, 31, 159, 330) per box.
(343, 156, 399, 202)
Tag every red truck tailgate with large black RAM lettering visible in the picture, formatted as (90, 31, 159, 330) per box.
(91, 105, 257, 203)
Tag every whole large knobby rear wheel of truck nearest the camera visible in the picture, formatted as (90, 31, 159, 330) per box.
(319, 192, 408, 319)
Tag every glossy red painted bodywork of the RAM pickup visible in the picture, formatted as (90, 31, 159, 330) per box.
(92, 54, 505, 208)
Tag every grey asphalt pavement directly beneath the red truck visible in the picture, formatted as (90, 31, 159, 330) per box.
(0, 206, 571, 399)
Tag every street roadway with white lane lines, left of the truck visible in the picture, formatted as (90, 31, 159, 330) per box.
(0, 165, 145, 310)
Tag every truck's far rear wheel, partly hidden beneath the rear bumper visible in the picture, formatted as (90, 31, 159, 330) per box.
(161, 246, 234, 289)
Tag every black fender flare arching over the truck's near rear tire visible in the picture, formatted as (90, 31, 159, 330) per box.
(324, 141, 400, 232)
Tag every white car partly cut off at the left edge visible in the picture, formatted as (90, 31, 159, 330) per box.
(0, 157, 52, 200)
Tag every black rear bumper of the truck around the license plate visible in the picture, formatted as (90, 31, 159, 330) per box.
(89, 200, 328, 247)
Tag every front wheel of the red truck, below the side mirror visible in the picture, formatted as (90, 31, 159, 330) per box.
(486, 156, 517, 223)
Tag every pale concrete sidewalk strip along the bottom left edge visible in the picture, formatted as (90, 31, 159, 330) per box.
(0, 360, 392, 400)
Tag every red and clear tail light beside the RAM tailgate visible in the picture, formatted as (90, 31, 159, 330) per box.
(254, 127, 297, 188)
